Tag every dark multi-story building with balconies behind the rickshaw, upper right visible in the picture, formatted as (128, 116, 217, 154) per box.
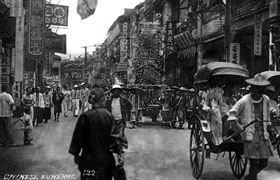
(175, 0, 279, 86)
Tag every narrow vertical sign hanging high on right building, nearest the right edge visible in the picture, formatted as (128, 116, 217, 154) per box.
(254, 14, 262, 56)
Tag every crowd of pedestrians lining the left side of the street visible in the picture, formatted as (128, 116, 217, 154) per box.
(0, 83, 90, 147)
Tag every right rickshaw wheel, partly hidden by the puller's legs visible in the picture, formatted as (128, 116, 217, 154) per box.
(229, 151, 248, 179)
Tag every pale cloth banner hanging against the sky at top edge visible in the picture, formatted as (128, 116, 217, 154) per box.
(77, 0, 97, 19)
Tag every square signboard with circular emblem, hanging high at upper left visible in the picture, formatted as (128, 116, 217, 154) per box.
(45, 4, 68, 26)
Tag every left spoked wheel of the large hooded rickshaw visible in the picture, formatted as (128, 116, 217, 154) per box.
(190, 121, 205, 179)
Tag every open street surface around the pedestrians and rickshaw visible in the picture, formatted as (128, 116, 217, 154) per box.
(0, 114, 280, 180)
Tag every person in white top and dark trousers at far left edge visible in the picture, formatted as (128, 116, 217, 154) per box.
(0, 84, 16, 147)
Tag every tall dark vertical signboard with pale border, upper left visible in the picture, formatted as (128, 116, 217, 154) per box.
(28, 0, 45, 56)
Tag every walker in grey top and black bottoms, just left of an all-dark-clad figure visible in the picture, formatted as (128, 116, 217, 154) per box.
(43, 86, 53, 124)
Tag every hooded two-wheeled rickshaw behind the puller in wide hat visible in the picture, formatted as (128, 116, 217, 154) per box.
(188, 62, 250, 178)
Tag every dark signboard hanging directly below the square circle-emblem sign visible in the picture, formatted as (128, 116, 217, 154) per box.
(46, 33, 66, 54)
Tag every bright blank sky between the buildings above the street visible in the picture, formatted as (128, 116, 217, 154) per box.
(51, 0, 144, 55)
